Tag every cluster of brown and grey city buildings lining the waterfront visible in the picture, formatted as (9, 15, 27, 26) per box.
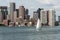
(0, 2, 56, 26)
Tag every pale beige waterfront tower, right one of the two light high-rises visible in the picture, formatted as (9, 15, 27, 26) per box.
(48, 9, 56, 26)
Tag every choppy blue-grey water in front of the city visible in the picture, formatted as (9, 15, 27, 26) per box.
(0, 27, 60, 40)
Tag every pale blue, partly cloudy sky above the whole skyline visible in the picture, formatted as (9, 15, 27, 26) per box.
(0, 0, 60, 20)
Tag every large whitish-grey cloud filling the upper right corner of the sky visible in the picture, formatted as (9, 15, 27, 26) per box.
(37, 0, 60, 9)
